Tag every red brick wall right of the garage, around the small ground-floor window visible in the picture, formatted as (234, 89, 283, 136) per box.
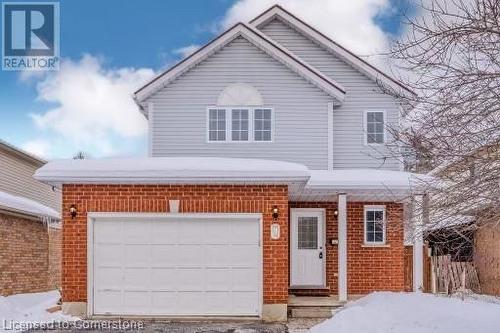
(289, 202, 404, 294)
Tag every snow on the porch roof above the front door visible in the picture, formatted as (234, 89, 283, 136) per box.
(307, 169, 431, 190)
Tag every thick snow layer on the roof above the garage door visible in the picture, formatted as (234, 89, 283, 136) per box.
(34, 157, 309, 185)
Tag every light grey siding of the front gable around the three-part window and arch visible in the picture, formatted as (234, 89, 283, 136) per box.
(147, 37, 333, 169)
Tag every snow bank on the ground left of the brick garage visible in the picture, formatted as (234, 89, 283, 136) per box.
(0, 290, 78, 333)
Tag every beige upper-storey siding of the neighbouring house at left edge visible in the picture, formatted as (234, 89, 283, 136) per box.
(0, 146, 61, 212)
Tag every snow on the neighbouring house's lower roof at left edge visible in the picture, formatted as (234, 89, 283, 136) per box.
(0, 191, 61, 219)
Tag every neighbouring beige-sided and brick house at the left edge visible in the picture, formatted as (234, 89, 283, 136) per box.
(0, 141, 62, 295)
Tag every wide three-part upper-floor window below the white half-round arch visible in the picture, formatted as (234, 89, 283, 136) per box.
(207, 107, 273, 142)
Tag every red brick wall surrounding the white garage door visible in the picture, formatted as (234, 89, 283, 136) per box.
(62, 185, 288, 304)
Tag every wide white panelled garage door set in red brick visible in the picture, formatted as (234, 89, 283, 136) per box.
(89, 214, 262, 316)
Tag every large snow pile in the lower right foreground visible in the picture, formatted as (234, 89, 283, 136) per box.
(310, 292, 500, 333)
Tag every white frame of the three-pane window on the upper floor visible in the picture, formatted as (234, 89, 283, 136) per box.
(205, 105, 275, 144)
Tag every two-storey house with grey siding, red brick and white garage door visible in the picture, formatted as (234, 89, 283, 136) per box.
(35, 6, 426, 320)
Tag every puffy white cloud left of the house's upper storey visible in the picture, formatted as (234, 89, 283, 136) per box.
(31, 55, 154, 156)
